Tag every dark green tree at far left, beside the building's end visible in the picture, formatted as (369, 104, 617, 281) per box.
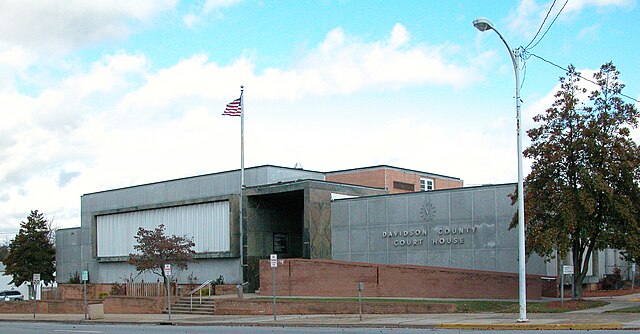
(2, 210, 56, 286)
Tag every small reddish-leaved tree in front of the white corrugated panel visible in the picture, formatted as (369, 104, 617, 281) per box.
(129, 224, 195, 285)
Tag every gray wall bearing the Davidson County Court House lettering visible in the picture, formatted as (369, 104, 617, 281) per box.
(331, 184, 546, 274)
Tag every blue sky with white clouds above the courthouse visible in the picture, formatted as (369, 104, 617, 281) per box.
(0, 0, 640, 242)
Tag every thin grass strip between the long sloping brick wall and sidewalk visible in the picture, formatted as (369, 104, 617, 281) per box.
(260, 297, 609, 313)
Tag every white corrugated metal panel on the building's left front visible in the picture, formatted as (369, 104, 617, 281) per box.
(97, 201, 230, 256)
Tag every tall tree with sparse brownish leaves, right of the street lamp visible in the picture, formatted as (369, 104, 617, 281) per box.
(511, 63, 640, 298)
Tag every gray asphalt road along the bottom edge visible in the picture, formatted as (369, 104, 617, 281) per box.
(0, 322, 629, 334)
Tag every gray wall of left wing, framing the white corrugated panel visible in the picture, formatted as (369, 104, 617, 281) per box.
(56, 166, 324, 283)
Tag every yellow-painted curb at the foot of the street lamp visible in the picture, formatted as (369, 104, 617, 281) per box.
(435, 322, 622, 330)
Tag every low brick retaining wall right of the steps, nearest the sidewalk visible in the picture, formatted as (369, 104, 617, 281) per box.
(215, 299, 456, 315)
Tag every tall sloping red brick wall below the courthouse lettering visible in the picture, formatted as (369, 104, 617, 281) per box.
(260, 259, 542, 299)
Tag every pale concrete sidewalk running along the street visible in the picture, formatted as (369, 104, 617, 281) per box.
(0, 294, 640, 330)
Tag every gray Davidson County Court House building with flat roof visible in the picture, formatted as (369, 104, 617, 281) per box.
(56, 165, 619, 289)
